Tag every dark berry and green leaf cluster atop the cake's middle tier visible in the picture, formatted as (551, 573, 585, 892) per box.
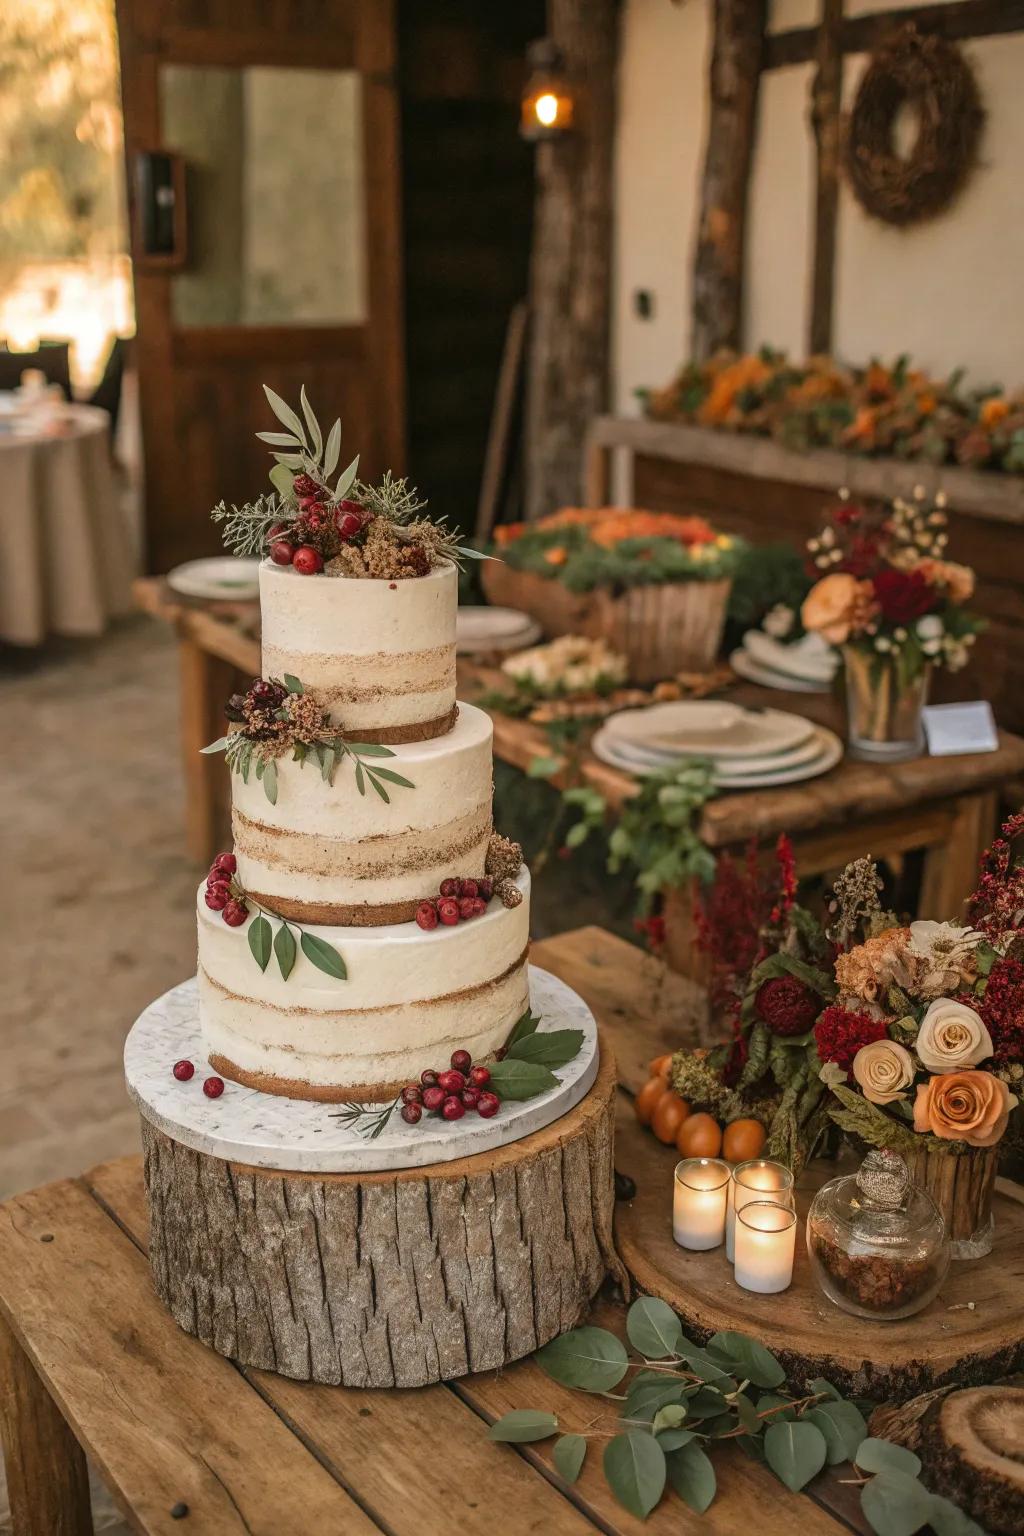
(203, 673, 413, 805)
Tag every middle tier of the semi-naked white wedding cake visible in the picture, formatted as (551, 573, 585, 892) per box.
(232, 700, 493, 925)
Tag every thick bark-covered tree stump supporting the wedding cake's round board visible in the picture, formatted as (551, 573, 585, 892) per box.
(143, 1040, 625, 1387)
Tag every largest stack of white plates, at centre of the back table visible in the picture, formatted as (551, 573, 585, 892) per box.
(591, 700, 843, 790)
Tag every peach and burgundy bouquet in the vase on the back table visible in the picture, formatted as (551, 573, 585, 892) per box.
(801, 485, 984, 685)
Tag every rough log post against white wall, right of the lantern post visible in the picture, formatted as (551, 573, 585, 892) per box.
(691, 0, 768, 358)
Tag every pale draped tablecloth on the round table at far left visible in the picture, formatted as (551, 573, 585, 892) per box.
(0, 406, 135, 645)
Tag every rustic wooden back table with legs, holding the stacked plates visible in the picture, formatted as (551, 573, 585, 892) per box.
(134, 578, 1024, 974)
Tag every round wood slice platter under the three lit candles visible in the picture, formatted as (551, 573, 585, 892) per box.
(616, 1109, 1024, 1401)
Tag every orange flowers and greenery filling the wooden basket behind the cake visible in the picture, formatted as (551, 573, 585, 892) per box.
(494, 507, 746, 593)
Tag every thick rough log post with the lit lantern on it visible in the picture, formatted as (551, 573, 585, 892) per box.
(525, 0, 619, 518)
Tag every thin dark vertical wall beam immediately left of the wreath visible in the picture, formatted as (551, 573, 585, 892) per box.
(808, 0, 843, 356)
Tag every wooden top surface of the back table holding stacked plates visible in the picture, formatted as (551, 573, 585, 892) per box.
(134, 576, 1024, 848)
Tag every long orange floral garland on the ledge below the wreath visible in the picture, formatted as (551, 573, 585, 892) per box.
(642, 347, 1024, 475)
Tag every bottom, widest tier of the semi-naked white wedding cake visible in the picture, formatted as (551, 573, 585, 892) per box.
(198, 869, 530, 1101)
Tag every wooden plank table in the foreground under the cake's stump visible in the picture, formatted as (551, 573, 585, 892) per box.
(0, 928, 866, 1536)
